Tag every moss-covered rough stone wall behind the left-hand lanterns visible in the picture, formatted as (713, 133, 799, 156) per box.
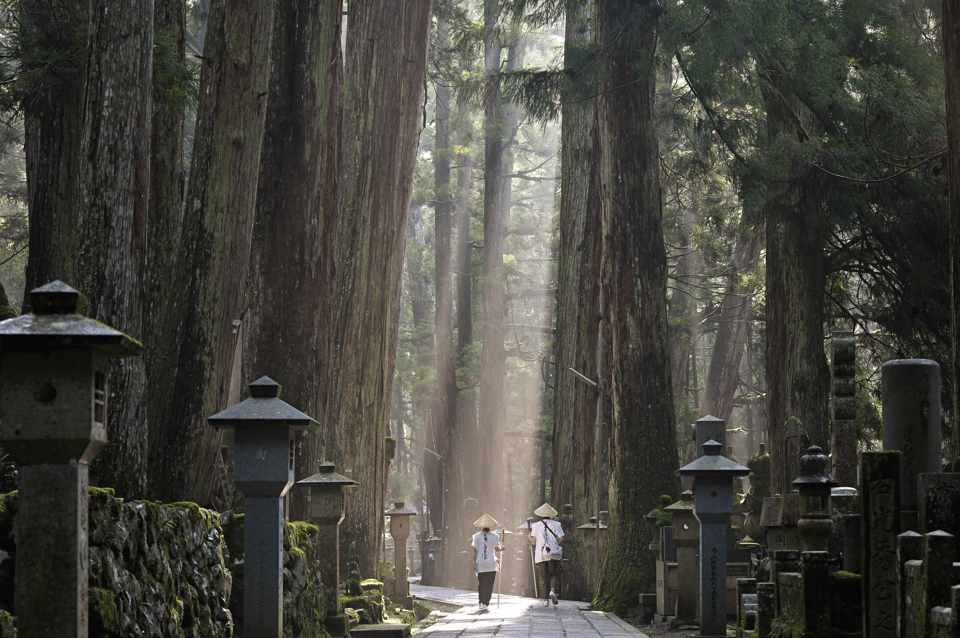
(0, 488, 329, 638)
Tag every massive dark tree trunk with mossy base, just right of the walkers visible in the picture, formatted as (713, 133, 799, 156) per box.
(594, 0, 677, 611)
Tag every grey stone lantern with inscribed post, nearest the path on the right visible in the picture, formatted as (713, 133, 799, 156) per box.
(678, 440, 750, 638)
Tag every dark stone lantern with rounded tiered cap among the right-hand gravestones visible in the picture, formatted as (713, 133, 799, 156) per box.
(793, 445, 837, 552)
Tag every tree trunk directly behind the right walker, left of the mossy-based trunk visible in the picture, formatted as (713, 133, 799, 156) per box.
(550, 2, 606, 600)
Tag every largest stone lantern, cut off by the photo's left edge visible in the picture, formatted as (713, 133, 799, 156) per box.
(0, 281, 143, 638)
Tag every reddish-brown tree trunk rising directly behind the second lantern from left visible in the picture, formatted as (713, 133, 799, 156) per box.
(242, 0, 343, 520)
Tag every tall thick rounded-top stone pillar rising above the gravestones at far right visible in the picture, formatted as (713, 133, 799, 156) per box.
(880, 359, 942, 531)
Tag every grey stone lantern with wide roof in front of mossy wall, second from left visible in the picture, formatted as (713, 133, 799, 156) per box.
(207, 377, 317, 638)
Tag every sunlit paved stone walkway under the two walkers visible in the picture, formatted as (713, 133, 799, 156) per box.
(410, 583, 647, 638)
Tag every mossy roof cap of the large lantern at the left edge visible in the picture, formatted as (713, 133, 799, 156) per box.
(0, 281, 143, 357)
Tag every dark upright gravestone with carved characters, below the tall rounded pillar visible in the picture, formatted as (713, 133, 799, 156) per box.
(860, 452, 900, 638)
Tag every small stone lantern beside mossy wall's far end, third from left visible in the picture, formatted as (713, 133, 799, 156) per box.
(297, 461, 357, 618)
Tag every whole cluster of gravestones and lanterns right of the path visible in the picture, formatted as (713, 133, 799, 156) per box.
(651, 358, 960, 638)
